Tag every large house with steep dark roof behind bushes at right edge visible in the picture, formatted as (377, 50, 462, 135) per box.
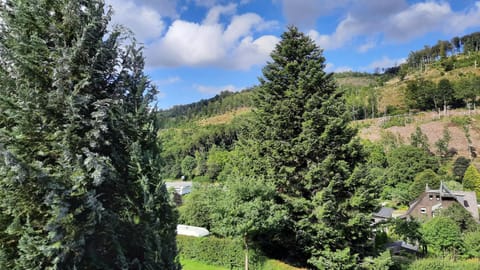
(405, 182, 479, 222)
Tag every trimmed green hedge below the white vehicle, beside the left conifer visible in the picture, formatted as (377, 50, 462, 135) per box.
(177, 235, 265, 269)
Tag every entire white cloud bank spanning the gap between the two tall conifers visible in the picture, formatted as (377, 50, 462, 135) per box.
(107, 0, 279, 70)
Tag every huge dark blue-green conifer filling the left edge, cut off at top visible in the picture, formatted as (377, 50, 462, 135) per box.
(0, 0, 179, 269)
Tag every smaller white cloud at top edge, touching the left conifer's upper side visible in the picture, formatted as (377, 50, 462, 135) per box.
(107, 0, 165, 42)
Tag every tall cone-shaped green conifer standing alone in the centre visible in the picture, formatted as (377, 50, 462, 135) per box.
(241, 27, 375, 268)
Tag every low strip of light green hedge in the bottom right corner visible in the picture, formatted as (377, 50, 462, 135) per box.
(408, 258, 480, 270)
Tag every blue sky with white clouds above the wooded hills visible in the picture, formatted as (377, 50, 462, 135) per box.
(106, 0, 480, 109)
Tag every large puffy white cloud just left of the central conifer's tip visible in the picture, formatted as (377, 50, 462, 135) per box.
(146, 5, 279, 69)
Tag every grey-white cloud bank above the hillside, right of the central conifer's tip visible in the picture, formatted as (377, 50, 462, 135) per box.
(306, 0, 480, 52)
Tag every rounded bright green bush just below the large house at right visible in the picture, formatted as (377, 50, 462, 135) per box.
(421, 216, 463, 255)
